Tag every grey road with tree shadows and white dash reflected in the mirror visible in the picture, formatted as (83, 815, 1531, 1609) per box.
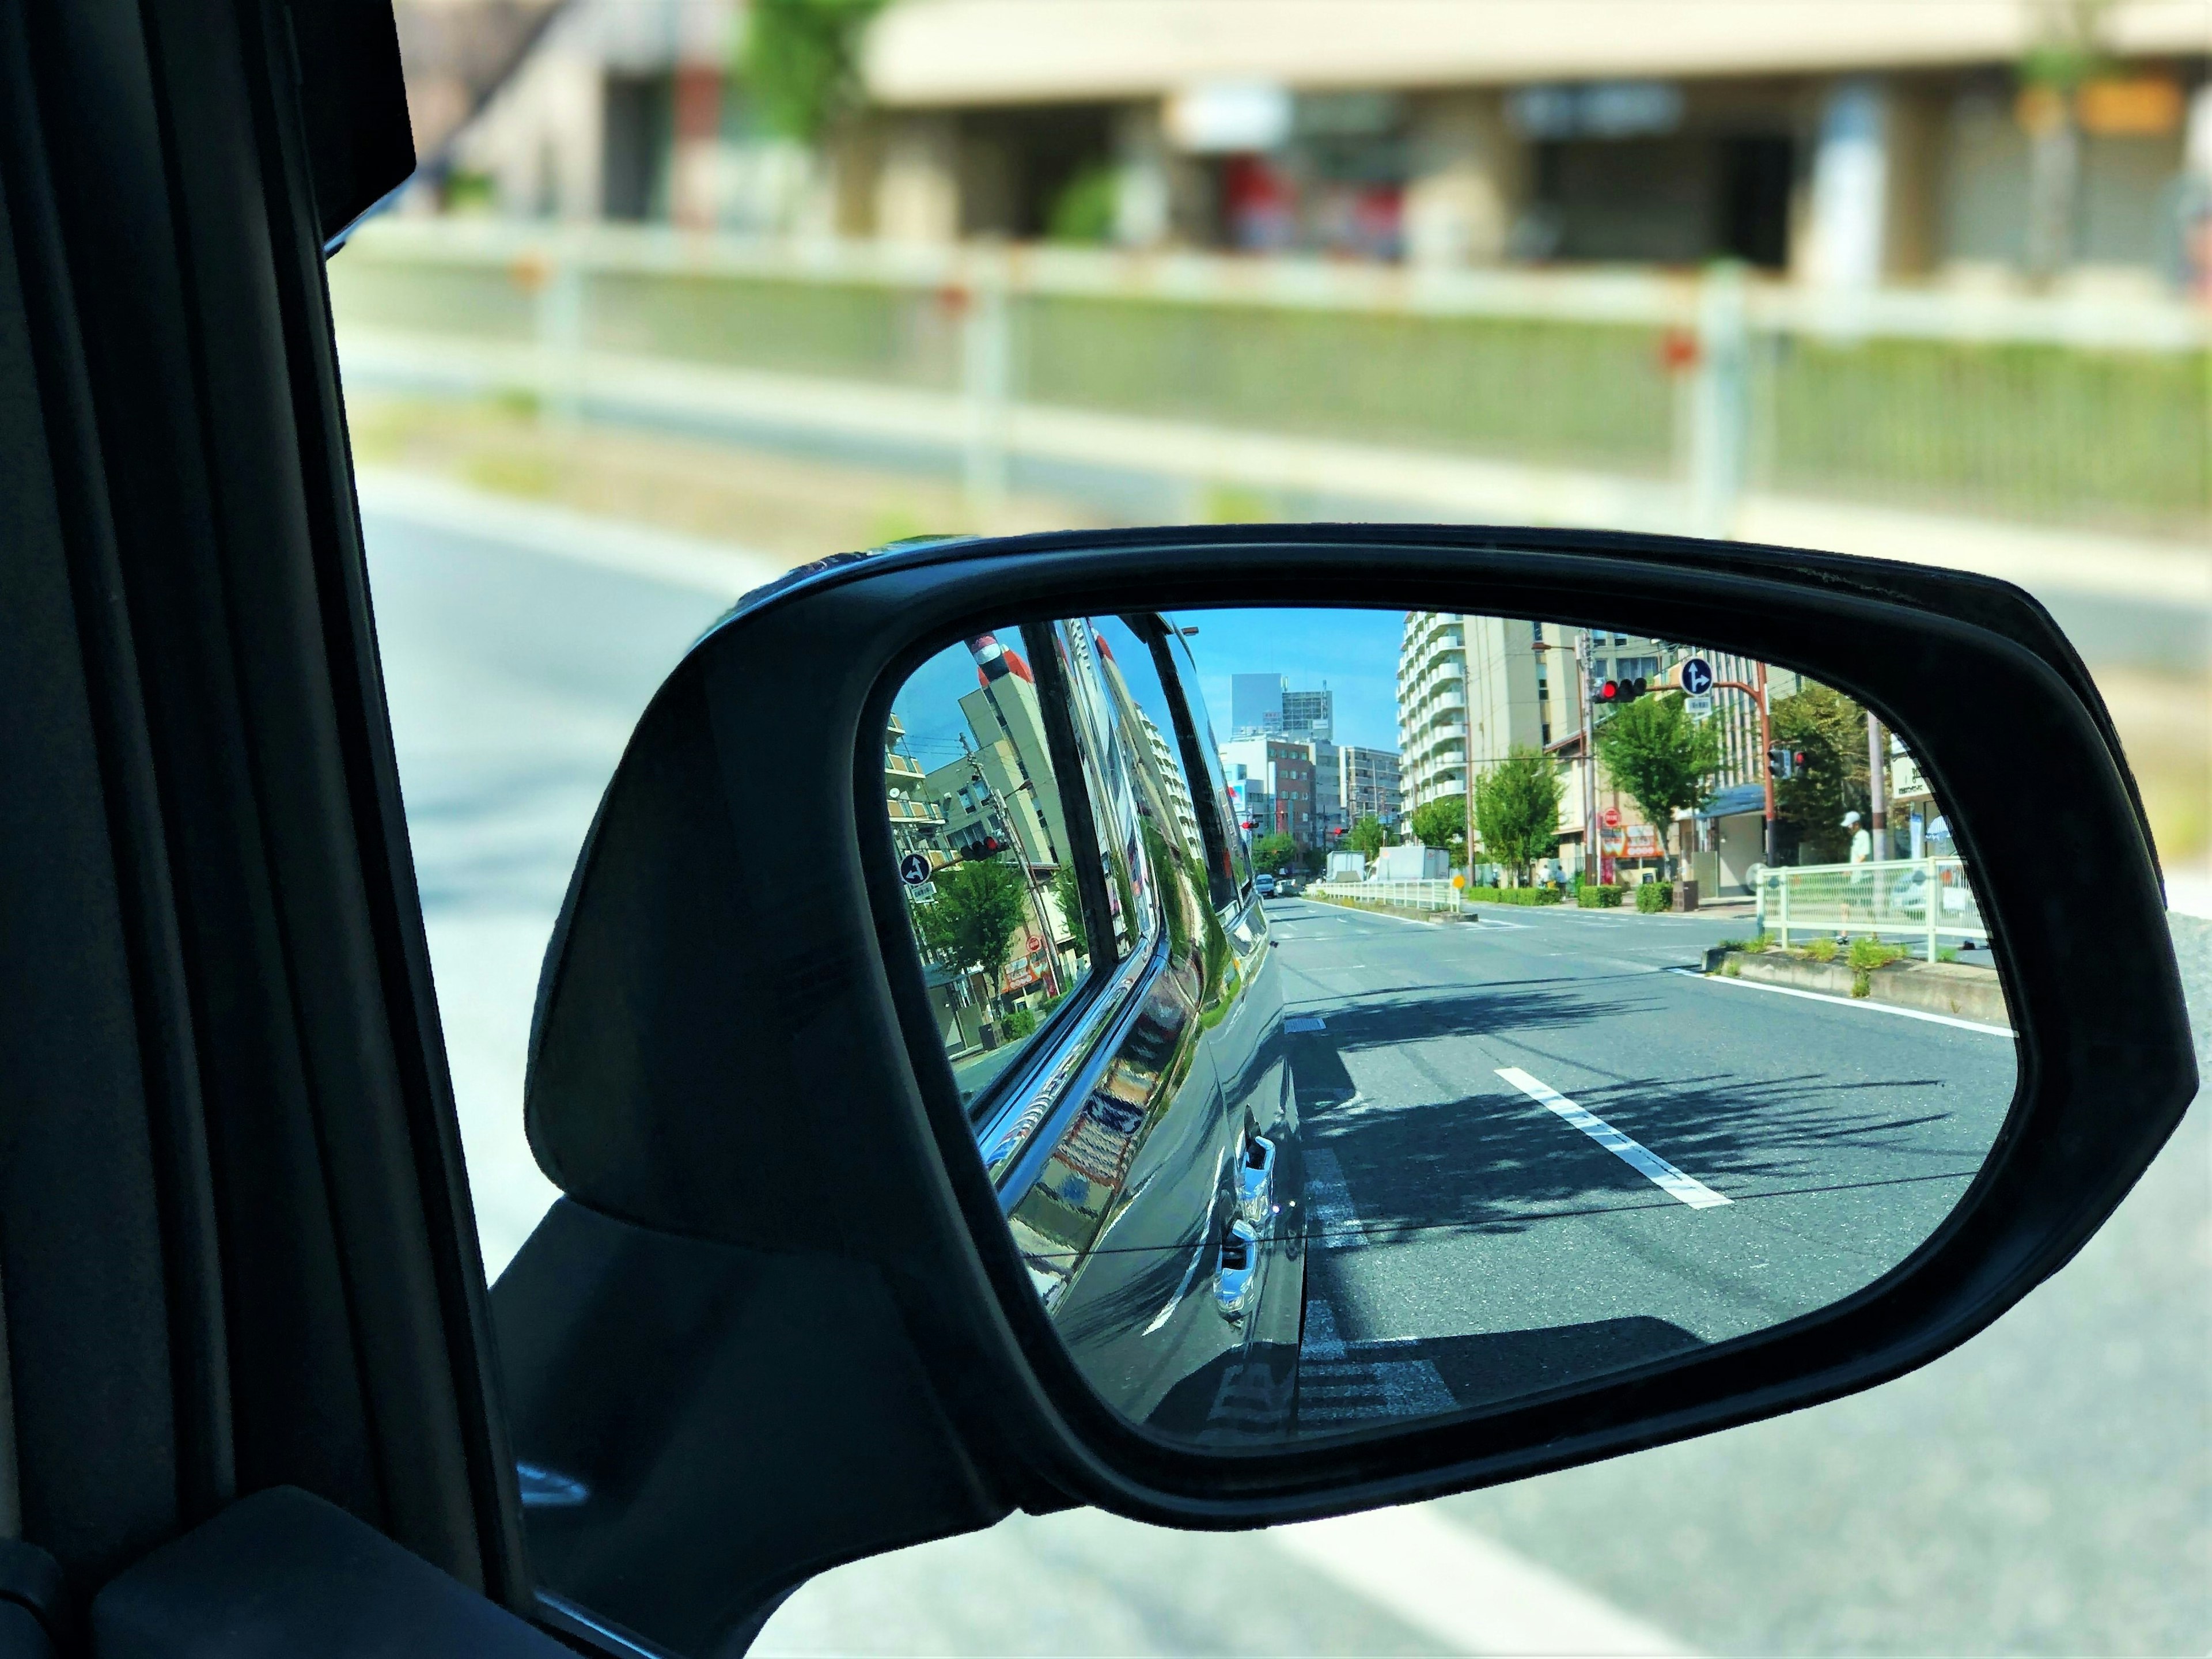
(1270, 898, 2015, 1431)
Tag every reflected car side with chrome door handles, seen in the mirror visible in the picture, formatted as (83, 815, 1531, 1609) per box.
(978, 617, 1305, 1442)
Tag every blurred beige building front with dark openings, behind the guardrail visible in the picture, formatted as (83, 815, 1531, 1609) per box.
(418, 0, 2212, 287)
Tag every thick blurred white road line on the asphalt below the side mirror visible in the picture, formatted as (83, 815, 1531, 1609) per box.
(1267, 1504, 1690, 1654)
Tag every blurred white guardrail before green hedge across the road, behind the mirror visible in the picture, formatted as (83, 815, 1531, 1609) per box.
(329, 219, 2212, 588)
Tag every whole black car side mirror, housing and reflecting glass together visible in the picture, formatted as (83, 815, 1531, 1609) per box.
(493, 527, 2196, 1652)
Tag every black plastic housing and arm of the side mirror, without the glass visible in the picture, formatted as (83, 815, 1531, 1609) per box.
(493, 527, 2196, 1650)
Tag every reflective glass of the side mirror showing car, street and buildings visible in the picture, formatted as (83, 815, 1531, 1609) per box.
(885, 608, 2017, 1449)
